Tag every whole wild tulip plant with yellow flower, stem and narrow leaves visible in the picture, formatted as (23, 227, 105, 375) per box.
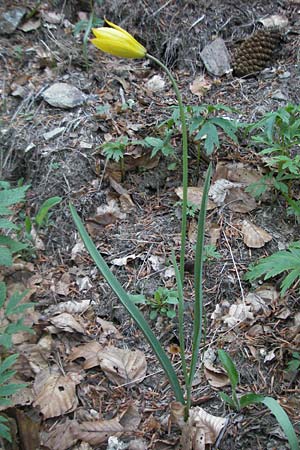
(70, 20, 298, 450)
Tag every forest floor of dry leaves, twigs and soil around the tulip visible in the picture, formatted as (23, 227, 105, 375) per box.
(0, 0, 300, 450)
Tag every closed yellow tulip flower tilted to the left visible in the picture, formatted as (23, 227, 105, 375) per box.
(91, 19, 147, 58)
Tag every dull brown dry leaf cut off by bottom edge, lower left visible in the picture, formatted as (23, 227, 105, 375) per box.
(42, 419, 79, 450)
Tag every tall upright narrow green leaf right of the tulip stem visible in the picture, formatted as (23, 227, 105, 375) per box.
(187, 165, 212, 406)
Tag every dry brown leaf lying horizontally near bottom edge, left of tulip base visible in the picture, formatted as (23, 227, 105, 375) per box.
(74, 418, 124, 445)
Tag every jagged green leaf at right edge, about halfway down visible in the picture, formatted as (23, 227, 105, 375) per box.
(245, 241, 300, 296)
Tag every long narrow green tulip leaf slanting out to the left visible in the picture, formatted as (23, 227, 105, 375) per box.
(70, 204, 184, 404)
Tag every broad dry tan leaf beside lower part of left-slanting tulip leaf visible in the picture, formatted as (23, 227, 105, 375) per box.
(98, 346, 147, 385)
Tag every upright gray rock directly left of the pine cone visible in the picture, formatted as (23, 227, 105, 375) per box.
(200, 38, 231, 76)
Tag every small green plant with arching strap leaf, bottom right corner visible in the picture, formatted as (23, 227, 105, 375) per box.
(218, 350, 299, 450)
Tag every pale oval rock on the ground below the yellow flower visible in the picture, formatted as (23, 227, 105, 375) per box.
(42, 83, 87, 109)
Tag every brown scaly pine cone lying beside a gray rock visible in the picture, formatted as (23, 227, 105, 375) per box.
(233, 29, 281, 77)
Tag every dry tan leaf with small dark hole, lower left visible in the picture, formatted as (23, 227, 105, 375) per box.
(33, 370, 80, 419)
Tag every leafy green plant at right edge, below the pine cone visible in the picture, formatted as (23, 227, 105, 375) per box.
(246, 104, 300, 217)
